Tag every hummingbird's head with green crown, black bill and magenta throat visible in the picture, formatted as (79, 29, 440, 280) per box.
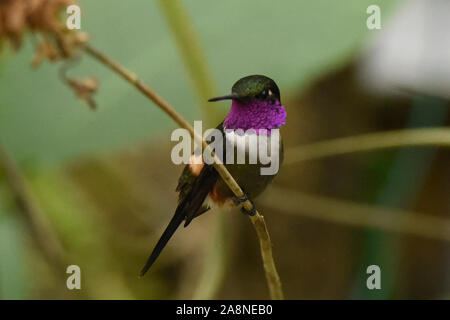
(209, 75, 286, 134)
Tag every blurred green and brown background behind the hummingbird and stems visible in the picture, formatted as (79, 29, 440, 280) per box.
(0, 0, 450, 299)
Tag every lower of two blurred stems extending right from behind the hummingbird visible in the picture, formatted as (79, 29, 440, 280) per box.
(261, 187, 450, 241)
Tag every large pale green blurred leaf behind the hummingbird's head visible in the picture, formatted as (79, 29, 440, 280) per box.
(0, 0, 396, 163)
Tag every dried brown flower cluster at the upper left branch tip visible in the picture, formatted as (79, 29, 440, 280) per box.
(0, 0, 98, 109)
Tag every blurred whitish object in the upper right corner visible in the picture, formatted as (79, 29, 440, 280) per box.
(358, 0, 450, 98)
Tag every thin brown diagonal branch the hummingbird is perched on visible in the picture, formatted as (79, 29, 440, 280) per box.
(83, 44, 284, 299)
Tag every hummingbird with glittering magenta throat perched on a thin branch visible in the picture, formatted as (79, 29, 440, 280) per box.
(141, 75, 286, 276)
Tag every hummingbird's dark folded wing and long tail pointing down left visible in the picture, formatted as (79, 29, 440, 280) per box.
(141, 164, 219, 276)
